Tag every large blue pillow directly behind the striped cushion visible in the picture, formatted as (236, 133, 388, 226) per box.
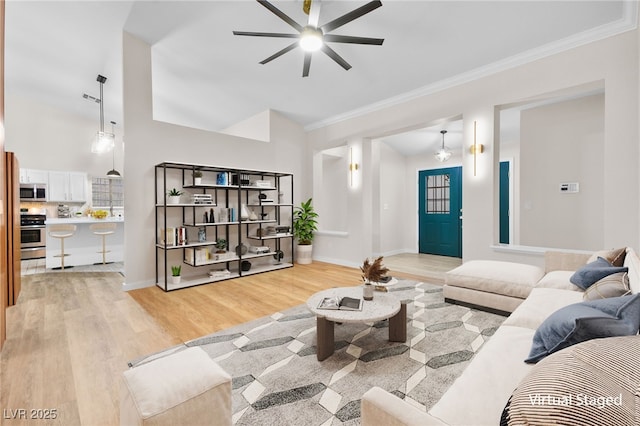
(525, 294, 640, 363)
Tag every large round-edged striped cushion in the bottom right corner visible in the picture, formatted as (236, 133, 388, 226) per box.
(500, 336, 640, 426)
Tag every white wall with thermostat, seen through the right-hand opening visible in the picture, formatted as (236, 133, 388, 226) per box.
(518, 95, 605, 250)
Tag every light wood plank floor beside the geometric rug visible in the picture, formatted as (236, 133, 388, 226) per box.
(0, 259, 456, 425)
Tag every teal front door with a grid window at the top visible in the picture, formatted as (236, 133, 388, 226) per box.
(418, 167, 462, 257)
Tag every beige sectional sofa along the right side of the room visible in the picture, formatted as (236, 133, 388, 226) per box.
(361, 249, 640, 426)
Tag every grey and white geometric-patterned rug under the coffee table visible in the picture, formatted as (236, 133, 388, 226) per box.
(129, 280, 505, 426)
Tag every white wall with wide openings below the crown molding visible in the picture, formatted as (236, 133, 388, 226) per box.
(308, 31, 640, 265)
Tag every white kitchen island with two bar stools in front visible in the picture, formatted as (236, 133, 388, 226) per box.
(45, 217, 124, 269)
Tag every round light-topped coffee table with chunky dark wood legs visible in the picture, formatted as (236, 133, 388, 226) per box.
(307, 286, 407, 361)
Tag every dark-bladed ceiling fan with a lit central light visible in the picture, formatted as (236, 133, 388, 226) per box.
(233, 0, 384, 77)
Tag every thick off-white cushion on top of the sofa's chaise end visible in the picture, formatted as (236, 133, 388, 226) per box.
(445, 260, 544, 299)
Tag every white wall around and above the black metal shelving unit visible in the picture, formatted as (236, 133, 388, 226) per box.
(123, 33, 310, 289)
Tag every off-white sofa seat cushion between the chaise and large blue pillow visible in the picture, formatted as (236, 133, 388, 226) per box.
(503, 287, 583, 332)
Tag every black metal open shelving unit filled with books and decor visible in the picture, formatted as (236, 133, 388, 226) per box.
(154, 162, 294, 291)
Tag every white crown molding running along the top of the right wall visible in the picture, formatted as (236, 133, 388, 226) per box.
(304, 0, 638, 132)
